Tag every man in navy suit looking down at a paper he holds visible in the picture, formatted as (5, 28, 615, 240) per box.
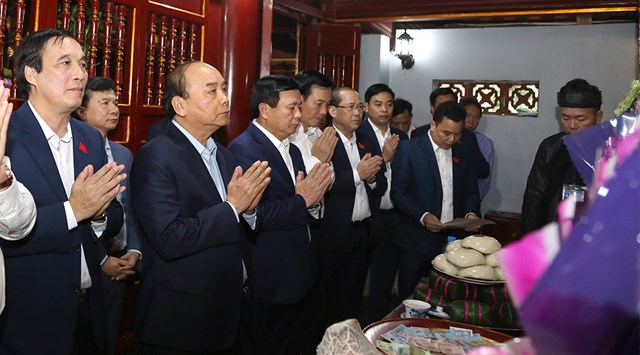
(391, 101, 480, 299)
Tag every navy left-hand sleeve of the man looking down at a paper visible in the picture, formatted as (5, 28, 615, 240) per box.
(391, 140, 426, 221)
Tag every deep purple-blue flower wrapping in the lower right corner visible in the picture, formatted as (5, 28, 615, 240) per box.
(520, 149, 640, 355)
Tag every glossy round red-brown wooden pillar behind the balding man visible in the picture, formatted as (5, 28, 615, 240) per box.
(219, 0, 271, 143)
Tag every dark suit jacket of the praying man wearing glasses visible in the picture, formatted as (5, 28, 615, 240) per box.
(319, 132, 387, 252)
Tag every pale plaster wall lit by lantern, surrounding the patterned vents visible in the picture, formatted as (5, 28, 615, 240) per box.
(360, 23, 637, 217)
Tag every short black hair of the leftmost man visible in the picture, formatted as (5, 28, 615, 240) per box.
(13, 27, 76, 100)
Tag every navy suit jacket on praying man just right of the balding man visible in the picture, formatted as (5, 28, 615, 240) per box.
(229, 123, 316, 304)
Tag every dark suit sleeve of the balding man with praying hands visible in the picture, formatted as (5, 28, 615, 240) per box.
(131, 150, 241, 261)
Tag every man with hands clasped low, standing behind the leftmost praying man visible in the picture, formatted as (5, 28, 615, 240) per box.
(76, 77, 142, 355)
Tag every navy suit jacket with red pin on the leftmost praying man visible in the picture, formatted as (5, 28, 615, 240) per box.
(0, 102, 122, 354)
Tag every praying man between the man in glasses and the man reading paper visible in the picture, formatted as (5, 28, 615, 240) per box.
(357, 83, 409, 323)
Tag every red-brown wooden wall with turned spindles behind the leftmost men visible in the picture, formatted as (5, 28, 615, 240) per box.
(0, 0, 215, 152)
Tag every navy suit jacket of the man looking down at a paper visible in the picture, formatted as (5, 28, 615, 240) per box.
(391, 135, 480, 255)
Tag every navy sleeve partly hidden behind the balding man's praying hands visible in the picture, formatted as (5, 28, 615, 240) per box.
(229, 142, 308, 232)
